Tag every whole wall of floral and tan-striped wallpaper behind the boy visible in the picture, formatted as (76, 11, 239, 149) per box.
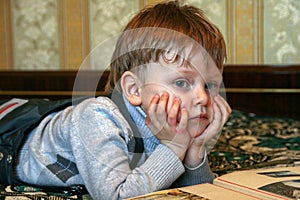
(0, 0, 300, 70)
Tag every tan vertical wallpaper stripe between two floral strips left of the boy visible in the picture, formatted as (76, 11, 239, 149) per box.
(58, 0, 90, 69)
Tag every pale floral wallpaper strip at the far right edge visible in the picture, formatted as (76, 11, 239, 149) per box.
(263, 0, 300, 63)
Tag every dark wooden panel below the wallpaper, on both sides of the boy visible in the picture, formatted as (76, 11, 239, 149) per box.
(0, 65, 300, 119)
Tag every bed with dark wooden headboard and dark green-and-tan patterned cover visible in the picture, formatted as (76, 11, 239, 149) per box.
(0, 66, 300, 200)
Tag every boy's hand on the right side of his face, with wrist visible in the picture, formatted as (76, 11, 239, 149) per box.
(184, 95, 232, 167)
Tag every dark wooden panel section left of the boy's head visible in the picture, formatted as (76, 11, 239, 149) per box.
(0, 71, 108, 91)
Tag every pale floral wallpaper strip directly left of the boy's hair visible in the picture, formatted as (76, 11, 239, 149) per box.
(88, 0, 140, 70)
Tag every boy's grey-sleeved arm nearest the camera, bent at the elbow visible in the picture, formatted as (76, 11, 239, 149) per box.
(70, 99, 185, 199)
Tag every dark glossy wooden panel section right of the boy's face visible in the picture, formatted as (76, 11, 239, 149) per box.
(223, 65, 300, 119)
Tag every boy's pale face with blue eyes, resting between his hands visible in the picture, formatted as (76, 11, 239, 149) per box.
(140, 56, 222, 137)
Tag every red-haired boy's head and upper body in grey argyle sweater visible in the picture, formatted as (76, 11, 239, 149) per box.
(0, 2, 231, 199)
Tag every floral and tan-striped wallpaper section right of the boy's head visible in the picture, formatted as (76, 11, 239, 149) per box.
(185, 0, 300, 64)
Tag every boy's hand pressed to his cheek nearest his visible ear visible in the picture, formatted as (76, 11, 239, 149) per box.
(146, 93, 190, 161)
